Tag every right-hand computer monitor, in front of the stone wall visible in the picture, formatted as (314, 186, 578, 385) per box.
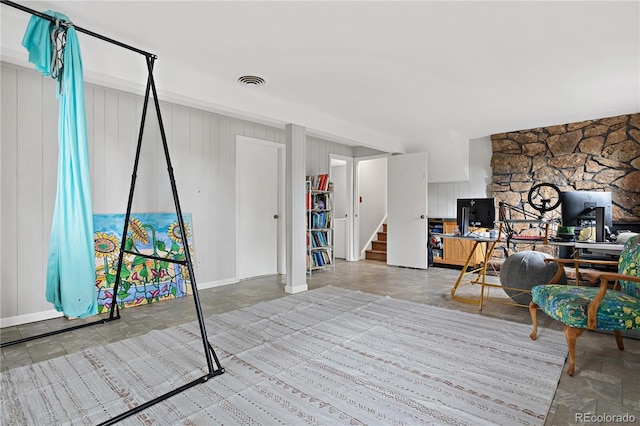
(560, 191, 613, 241)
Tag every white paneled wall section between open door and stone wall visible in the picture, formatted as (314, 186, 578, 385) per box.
(428, 136, 492, 218)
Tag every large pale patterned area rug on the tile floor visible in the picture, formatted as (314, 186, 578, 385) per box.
(0, 287, 566, 426)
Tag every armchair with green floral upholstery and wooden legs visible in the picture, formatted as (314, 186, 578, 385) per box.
(529, 234, 640, 376)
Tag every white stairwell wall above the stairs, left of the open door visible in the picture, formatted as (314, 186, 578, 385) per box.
(356, 157, 387, 254)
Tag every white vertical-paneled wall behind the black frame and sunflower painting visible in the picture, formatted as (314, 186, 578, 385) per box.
(0, 63, 302, 323)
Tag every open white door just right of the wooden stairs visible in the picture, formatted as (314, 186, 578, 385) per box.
(387, 152, 428, 269)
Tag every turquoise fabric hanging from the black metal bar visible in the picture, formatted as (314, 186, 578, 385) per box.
(22, 11, 98, 318)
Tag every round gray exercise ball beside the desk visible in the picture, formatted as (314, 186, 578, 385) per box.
(500, 251, 567, 305)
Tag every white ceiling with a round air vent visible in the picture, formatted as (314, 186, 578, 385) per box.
(1, 1, 640, 152)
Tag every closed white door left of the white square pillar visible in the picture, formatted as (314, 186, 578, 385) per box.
(236, 136, 280, 279)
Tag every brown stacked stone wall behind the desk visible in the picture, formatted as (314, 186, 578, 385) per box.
(491, 113, 640, 224)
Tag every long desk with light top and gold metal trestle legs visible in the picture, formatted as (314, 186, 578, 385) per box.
(441, 232, 624, 310)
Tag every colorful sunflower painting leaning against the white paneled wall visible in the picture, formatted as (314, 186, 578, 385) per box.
(93, 213, 195, 312)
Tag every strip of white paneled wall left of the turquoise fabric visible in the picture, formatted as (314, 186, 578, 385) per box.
(0, 68, 57, 316)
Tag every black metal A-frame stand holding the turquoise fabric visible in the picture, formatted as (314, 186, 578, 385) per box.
(0, 0, 224, 425)
